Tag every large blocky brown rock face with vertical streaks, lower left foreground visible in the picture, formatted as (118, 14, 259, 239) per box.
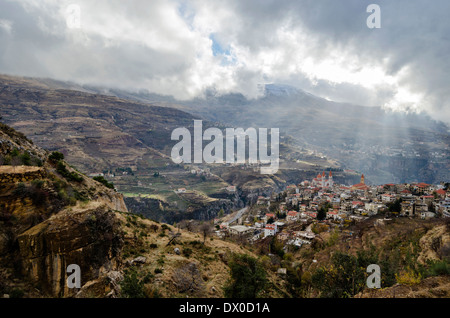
(18, 206, 122, 297)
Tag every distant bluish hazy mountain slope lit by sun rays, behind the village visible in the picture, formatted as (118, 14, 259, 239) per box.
(89, 84, 450, 184)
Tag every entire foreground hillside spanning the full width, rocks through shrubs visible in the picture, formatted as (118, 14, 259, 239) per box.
(0, 124, 450, 298)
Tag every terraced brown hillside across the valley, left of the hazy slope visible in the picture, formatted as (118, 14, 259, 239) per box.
(0, 75, 355, 223)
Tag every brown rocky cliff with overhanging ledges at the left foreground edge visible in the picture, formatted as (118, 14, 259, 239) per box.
(0, 120, 127, 297)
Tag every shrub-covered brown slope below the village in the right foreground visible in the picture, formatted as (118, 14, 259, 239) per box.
(293, 217, 450, 298)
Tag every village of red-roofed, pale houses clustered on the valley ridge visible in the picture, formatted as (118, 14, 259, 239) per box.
(214, 171, 450, 248)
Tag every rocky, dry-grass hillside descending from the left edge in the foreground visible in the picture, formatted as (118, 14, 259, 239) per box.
(0, 124, 285, 298)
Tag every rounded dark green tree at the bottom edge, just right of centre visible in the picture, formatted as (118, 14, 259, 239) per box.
(224, 254, 268, 298)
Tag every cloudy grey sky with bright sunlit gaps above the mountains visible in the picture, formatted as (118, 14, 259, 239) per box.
(0, 0, 450, 123)
